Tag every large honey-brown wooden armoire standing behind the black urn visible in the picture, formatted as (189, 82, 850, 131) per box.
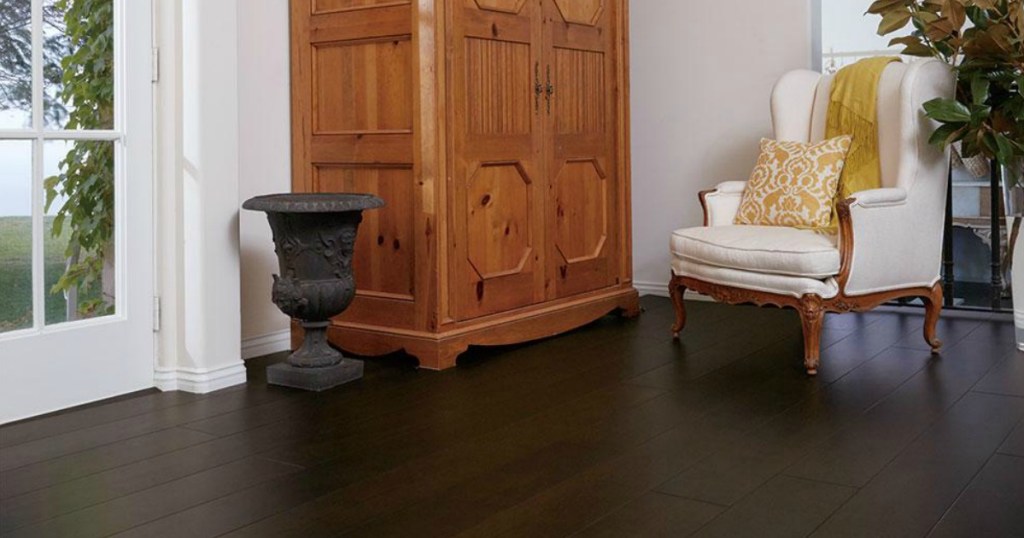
(291, 0, 639, 369)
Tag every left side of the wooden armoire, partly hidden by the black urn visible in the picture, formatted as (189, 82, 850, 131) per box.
(293, 0, 419, 329)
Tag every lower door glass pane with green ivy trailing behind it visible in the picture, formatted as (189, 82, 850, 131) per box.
(43, 140, 116, 324)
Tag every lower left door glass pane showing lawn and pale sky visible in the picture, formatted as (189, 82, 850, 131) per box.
(0, 140, 32, 333)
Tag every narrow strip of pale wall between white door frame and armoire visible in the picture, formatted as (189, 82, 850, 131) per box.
(238, 0, 292, 359)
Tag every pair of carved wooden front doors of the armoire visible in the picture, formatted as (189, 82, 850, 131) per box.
(450, 0, 618, 319)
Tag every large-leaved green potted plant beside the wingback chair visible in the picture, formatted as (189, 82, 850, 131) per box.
(867, 0, 1024, 342)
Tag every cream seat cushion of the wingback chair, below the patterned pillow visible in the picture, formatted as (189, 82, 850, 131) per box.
(672, 225, 840, 279)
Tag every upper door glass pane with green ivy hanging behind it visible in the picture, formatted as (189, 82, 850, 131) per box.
(43, 0, 114, 129)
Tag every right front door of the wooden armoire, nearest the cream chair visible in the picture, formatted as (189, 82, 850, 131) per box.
(545, 0, 621, 298)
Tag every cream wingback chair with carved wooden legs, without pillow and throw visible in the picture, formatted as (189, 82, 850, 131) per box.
(670, 60, 953, 375)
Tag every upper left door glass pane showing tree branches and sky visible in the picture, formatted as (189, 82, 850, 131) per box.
(0, 0, 32, 129)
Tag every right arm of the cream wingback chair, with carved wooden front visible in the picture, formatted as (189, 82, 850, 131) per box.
(837, 189, 942, 295)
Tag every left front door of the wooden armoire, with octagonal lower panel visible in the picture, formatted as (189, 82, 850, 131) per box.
(449, 0, 546, 320)
